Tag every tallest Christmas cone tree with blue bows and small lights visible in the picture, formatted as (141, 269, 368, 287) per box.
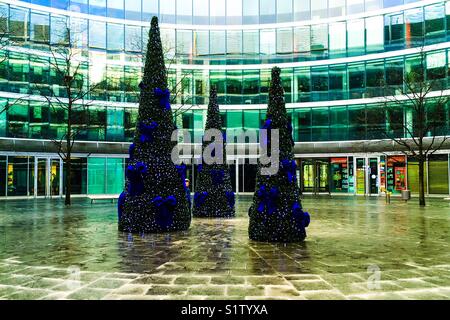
(118, 17, 191, 233)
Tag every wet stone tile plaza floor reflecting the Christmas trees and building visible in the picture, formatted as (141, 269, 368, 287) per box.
(0, 197, 450, 299)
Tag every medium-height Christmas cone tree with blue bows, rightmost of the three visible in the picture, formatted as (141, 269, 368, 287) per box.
(248, 67, 309, 242)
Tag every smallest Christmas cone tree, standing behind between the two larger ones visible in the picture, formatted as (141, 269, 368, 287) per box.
(192, 88, 235, 217)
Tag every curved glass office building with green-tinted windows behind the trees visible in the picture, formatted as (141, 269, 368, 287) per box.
(0, 0, 450, 197)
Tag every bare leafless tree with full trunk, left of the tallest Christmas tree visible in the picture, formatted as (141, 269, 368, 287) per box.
(35, 25, 105, 205)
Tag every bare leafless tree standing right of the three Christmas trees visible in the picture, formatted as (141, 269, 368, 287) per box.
(371, 47, 450, 206)
